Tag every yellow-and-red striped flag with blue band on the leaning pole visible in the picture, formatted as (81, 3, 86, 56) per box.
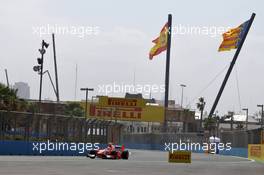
(218, 21, 249, 52)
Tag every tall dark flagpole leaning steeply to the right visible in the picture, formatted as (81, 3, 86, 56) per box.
(209, 13, 256, 117)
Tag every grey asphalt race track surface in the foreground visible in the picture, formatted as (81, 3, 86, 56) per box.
(0, 150, 264, 175)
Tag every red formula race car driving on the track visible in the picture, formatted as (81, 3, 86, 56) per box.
(87, 144, 129, 160)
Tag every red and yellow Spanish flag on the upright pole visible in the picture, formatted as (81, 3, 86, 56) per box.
(149, 23, 169, 60)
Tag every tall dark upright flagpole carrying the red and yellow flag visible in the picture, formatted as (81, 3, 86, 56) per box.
(163, 14, 172, 132)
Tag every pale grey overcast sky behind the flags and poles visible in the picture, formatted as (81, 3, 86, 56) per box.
(0, 0, 264, 113)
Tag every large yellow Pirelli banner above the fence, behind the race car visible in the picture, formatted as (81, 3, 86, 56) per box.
(82, 96, 164, 123)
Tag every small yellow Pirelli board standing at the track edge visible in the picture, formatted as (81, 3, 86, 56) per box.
(169, 151, 192, 163)
